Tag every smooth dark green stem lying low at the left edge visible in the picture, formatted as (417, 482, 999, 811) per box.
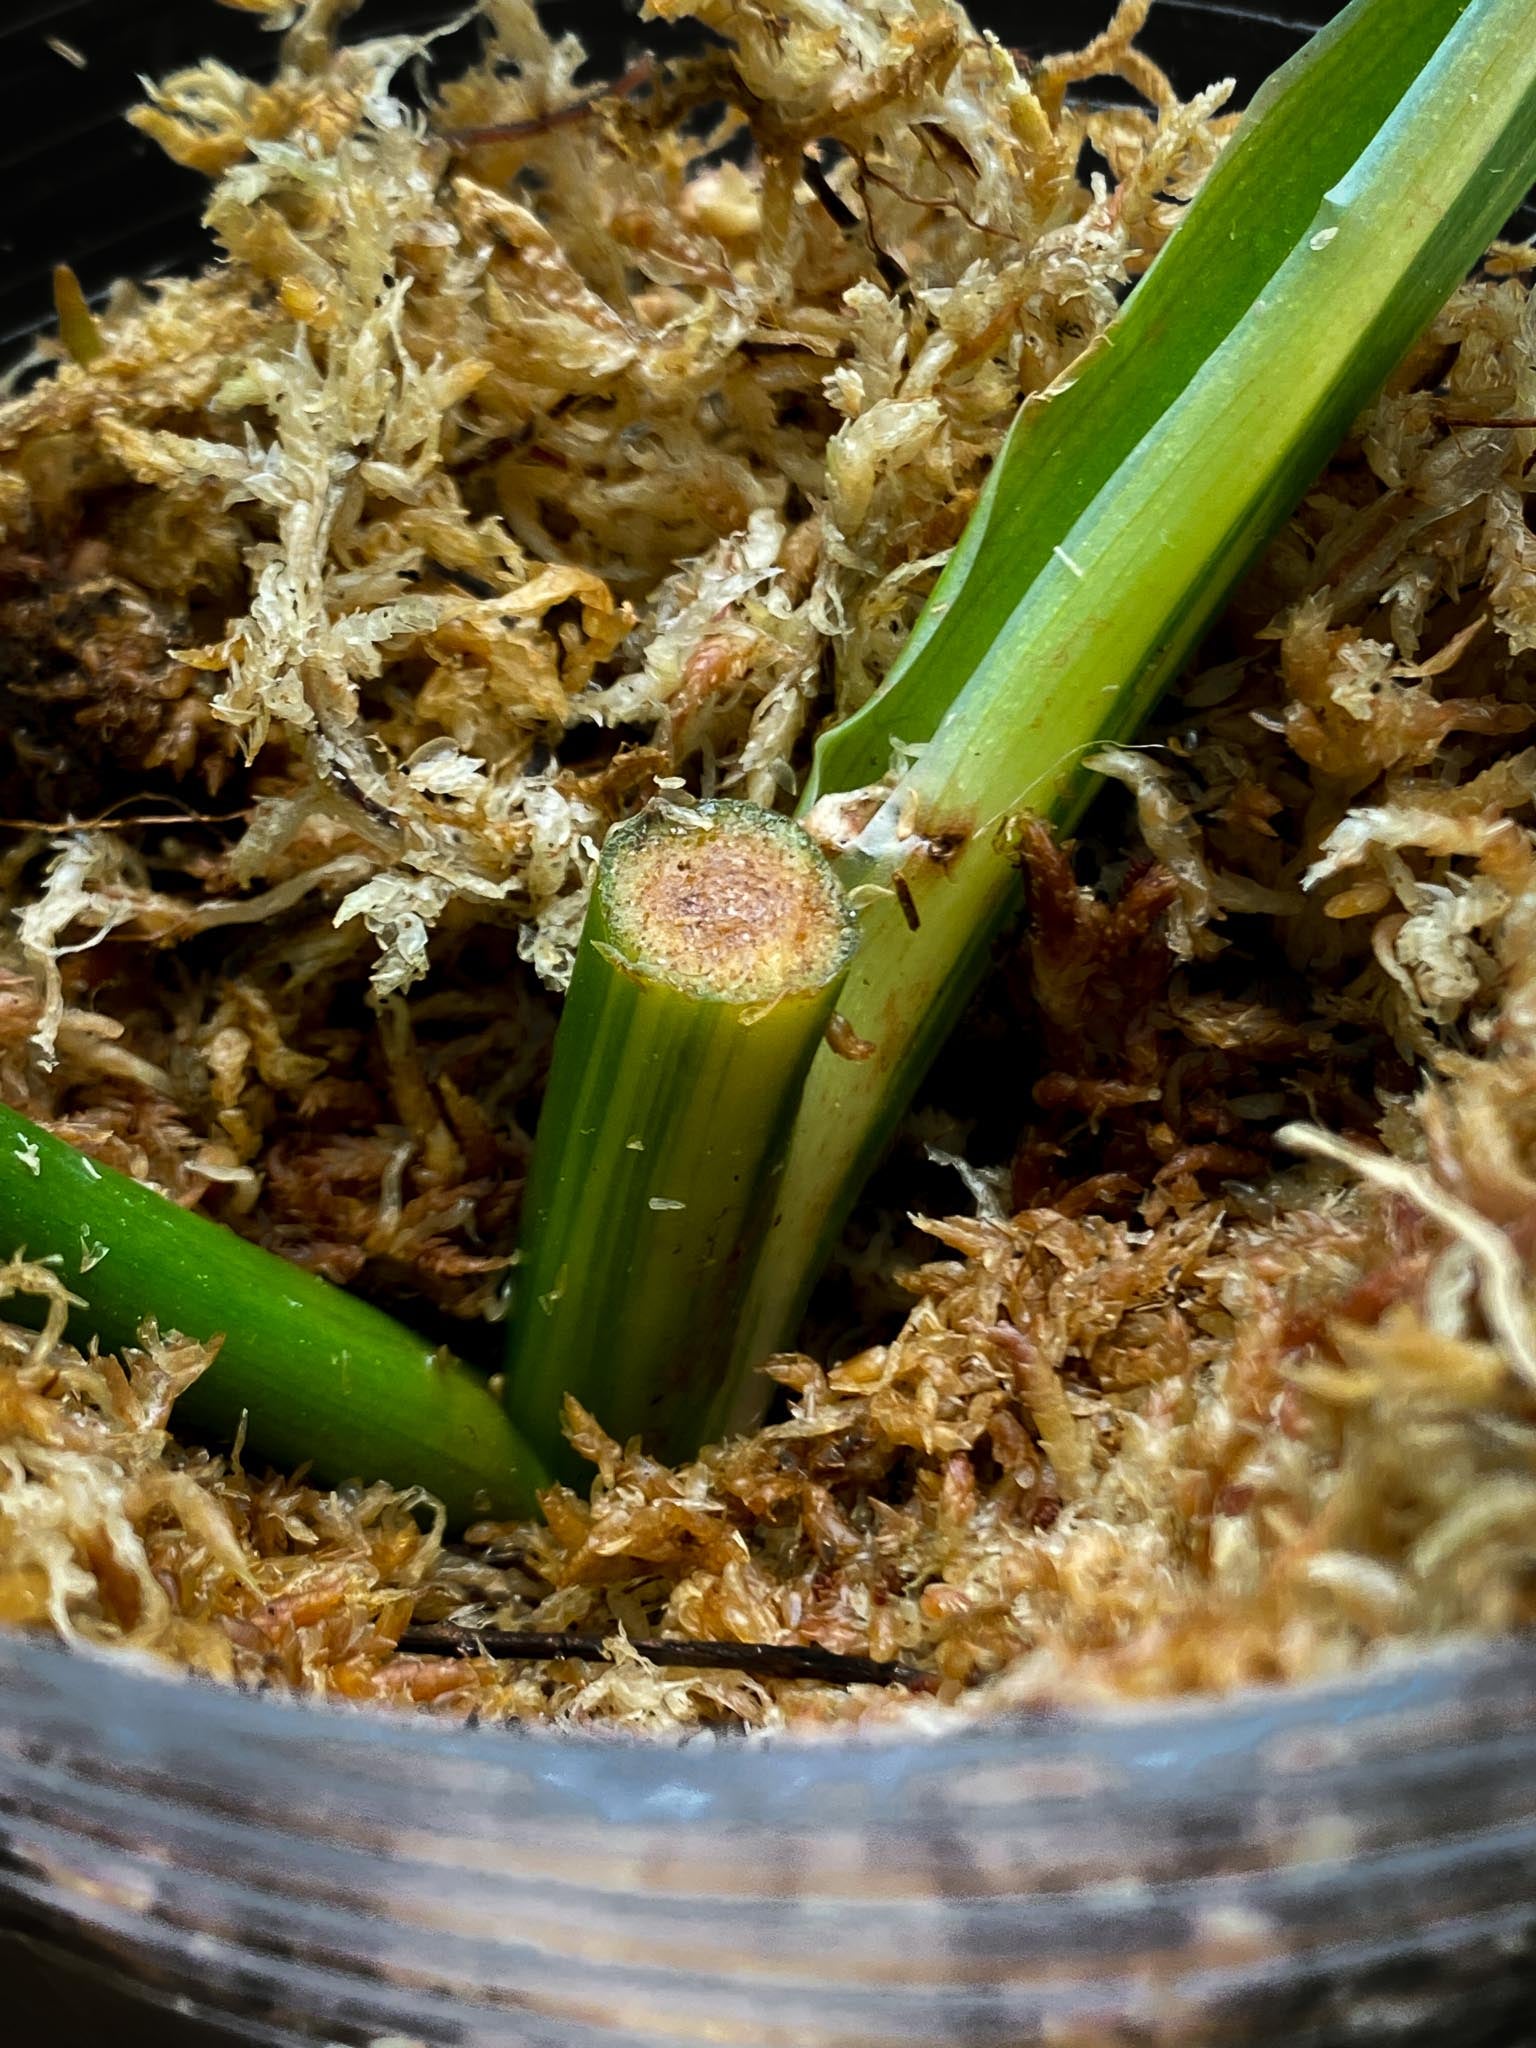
(0, 1106, 549, 1528)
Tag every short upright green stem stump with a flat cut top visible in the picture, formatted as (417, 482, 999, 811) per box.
(506, 799, 856, 1470)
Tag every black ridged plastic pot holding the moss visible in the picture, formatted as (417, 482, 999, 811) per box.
(0, 0, 1536, 2048)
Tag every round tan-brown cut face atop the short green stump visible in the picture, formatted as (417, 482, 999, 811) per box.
(602, 801, 854, 1004)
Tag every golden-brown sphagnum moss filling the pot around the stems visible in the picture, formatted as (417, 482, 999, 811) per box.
(0, 0, 1536, 1731)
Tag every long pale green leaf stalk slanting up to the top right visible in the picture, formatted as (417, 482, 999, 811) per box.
(729, 0, 1536, 1425)
